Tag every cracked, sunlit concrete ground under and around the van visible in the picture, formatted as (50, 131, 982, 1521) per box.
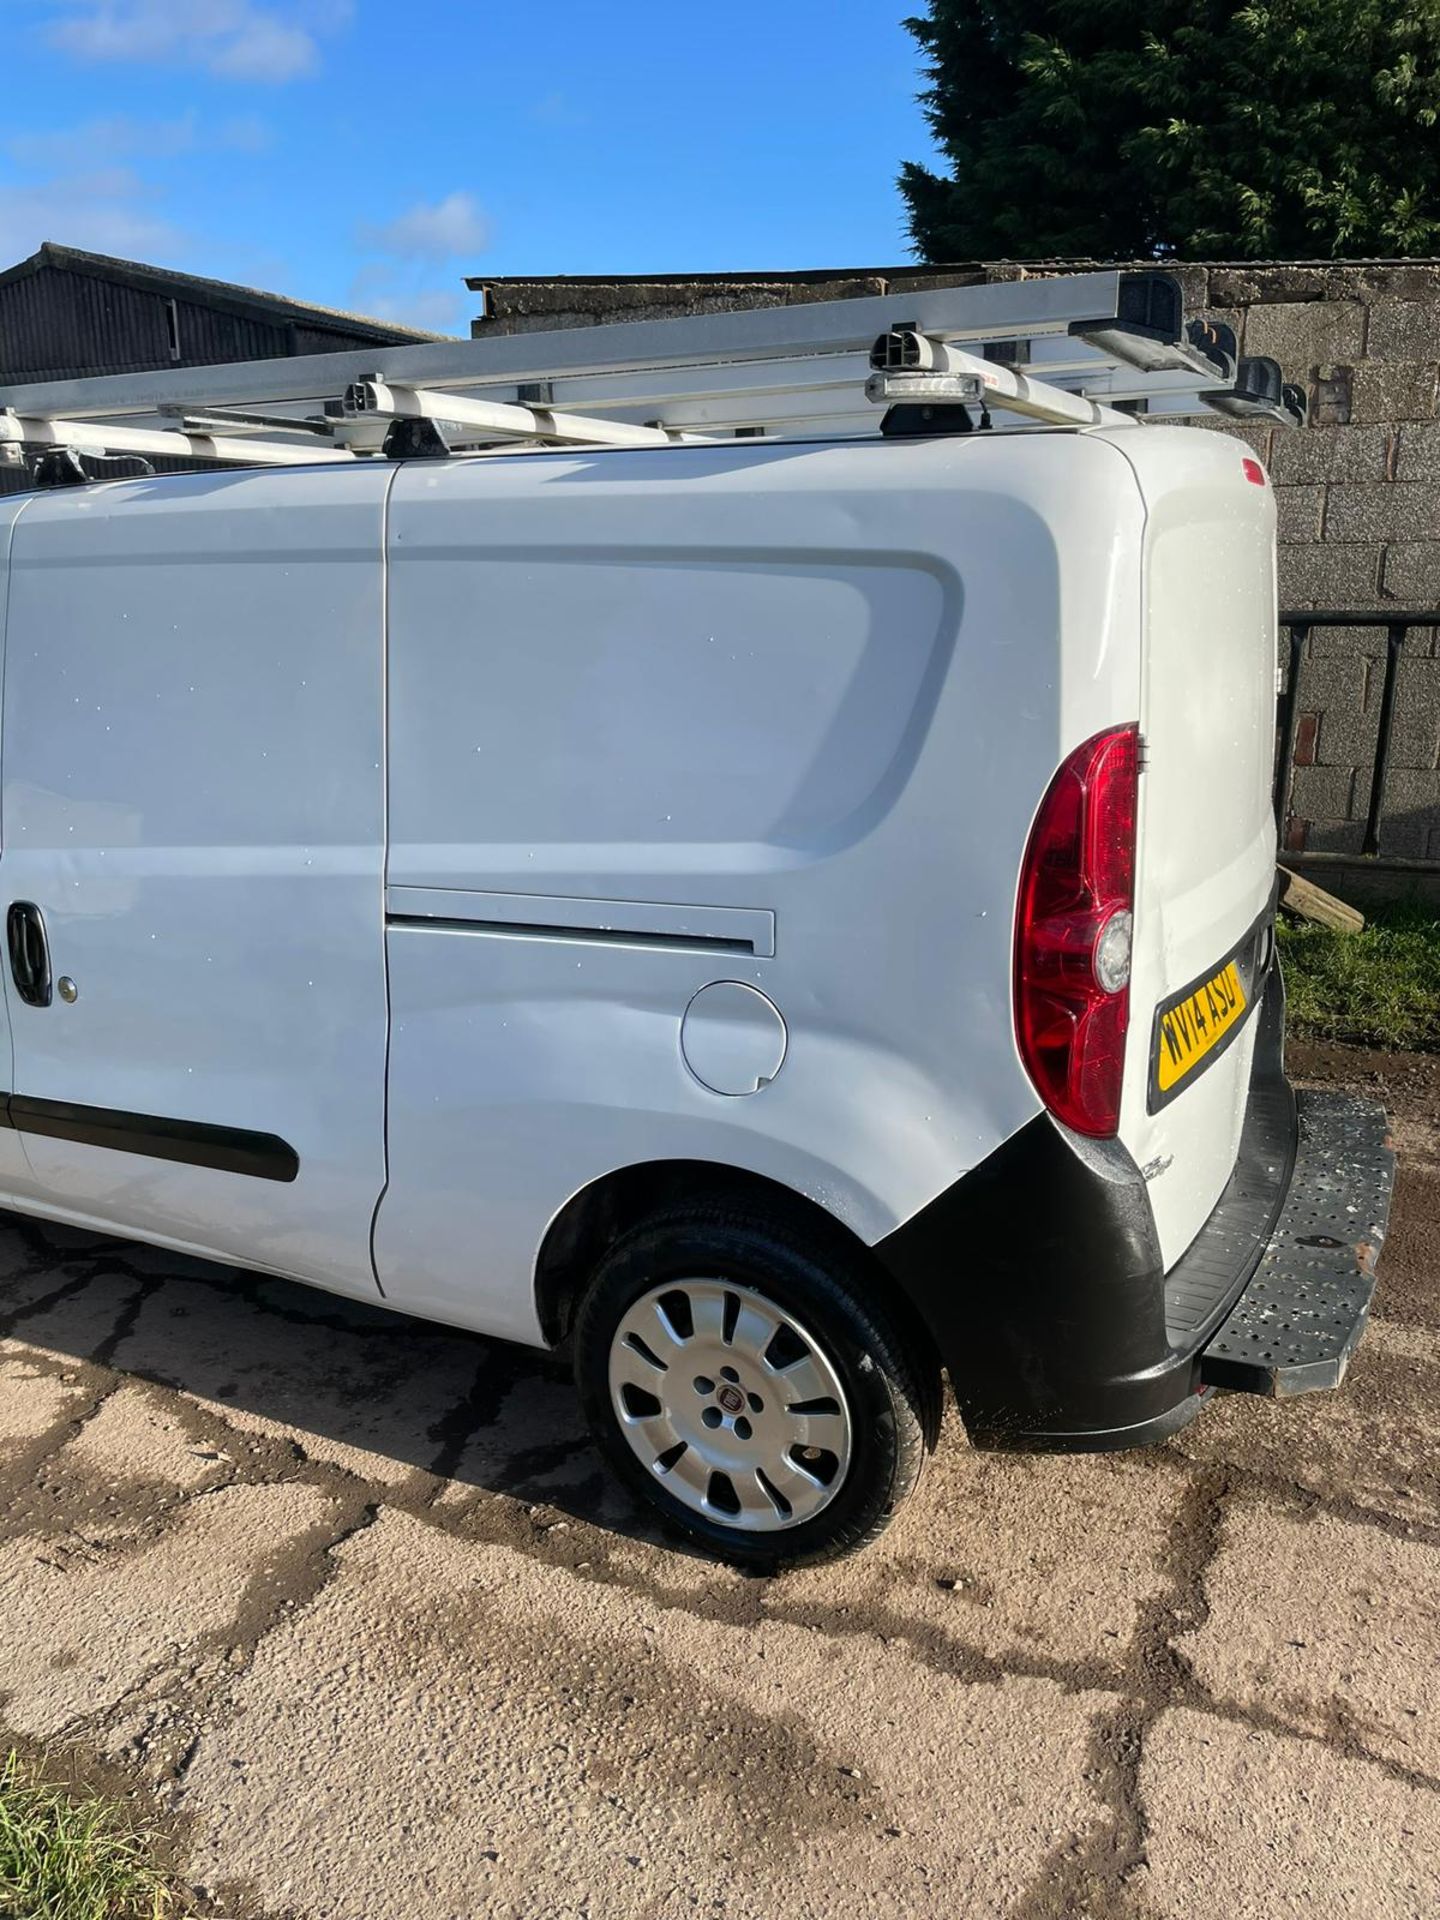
(0, 1052, 1440, 1920)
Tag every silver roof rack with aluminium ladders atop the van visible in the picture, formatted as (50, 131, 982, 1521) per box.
(0, 269, 1306, 484)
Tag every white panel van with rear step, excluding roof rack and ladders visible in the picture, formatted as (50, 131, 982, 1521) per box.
(0, 405, 1390, 1567)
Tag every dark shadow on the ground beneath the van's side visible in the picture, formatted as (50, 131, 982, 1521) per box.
(0, 1213, 676, 1546)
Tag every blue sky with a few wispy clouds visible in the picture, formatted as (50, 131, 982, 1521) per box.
(0, 0, 929, 332)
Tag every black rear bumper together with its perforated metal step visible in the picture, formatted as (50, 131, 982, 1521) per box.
(877, 970, 1394, 1452)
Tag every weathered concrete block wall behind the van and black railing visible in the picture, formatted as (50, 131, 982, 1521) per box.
(481, 261, 1440, 889)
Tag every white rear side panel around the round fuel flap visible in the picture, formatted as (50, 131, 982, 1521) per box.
(376, 434, 1142, 1342)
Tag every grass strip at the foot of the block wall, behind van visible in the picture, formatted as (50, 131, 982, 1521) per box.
(1279, 904, 1440, 1052)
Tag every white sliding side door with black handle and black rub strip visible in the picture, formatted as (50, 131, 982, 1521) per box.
(0, 468, 390, 1292)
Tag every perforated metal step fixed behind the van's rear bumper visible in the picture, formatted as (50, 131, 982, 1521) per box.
(1200, 1092, 1396, 1396)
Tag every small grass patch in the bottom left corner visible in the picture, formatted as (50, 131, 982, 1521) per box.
(0, 1753, 180, 1920)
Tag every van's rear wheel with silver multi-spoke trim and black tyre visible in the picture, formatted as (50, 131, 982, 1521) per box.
(574, 1208, 939, 1571)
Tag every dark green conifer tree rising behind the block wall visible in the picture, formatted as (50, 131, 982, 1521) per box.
(900, 0, 1440, 261)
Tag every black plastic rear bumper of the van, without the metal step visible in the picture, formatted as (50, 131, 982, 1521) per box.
(876, 956, 1296, 1452)
